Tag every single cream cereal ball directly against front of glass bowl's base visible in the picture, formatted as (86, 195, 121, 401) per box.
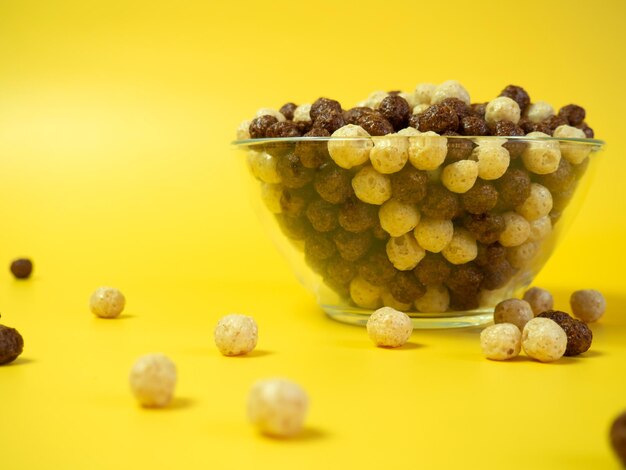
(367, 307, 413, 348)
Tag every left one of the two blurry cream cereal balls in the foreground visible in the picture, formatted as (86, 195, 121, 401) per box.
(129, 353, 176, 408)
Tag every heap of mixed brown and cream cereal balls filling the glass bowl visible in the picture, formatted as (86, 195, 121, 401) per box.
(237, 80, 593, 313)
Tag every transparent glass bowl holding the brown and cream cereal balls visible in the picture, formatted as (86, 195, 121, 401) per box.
(233, 135, 604, 328)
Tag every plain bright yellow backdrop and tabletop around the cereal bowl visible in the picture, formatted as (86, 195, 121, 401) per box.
(0, 0, 626, 469)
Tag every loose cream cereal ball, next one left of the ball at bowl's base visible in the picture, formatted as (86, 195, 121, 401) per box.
(214, 313, 259, 356)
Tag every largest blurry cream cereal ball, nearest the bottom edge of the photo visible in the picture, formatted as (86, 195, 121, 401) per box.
(248, 378, 309, 437)
